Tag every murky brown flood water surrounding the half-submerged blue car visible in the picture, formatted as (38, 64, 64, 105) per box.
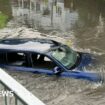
(0, 0, 105, 105)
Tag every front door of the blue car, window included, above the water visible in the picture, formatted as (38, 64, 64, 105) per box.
(30, 53, 56, 75)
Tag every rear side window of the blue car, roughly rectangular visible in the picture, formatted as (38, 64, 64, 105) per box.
(6, 52, 28, 66)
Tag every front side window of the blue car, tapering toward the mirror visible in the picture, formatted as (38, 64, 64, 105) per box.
(31, 54, 57, 69)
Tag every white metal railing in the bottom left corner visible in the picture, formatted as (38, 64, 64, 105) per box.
(0, 69, 45, 105)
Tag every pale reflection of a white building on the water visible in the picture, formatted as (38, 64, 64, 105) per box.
(13, 0, 78, 31)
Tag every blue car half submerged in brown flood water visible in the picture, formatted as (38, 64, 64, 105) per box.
(0, 38, 101, 82)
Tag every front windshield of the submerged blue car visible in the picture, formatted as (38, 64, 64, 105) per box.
(52, 46, 78, 69)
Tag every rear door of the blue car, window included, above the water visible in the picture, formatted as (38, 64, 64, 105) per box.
(1, 51, 34, 72)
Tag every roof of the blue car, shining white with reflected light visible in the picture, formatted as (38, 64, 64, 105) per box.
(0, 38, 61, 53)
